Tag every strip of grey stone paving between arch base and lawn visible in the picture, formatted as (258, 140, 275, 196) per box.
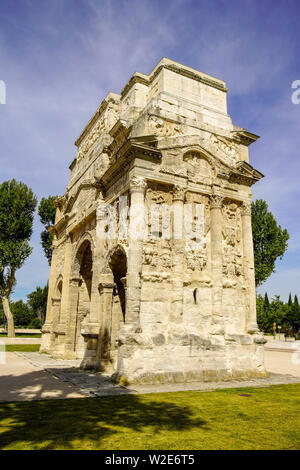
(17, 352, 300, 397)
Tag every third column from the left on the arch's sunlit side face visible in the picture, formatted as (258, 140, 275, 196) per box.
(210, 194, 224, 335)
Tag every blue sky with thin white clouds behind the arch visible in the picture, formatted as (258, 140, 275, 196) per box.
(0, 0, 300, 300)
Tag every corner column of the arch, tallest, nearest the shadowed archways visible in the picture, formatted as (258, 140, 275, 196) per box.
(125, 176, 147, 328)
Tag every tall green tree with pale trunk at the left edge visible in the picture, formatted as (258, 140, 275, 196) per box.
(0, 179, 37, 336)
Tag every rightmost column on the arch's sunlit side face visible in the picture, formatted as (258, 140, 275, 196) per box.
(242, 202, 259, 333)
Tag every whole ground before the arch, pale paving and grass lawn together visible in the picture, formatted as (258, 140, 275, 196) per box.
(0, 342, 300, 450)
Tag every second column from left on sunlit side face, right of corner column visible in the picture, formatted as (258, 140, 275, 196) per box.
(171, 185, 185, 323)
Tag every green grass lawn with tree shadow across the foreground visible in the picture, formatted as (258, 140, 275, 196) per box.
(0, 384, 300, 450)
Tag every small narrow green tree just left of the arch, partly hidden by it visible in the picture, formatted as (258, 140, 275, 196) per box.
(38, 196, 57, 264)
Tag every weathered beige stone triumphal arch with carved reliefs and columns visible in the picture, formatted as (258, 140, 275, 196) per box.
(41, 58, 265, 383)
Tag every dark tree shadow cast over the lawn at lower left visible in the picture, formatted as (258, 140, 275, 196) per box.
(0, 372, 207, 449)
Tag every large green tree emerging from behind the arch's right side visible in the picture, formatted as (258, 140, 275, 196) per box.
(252, 199, 289, 286)
